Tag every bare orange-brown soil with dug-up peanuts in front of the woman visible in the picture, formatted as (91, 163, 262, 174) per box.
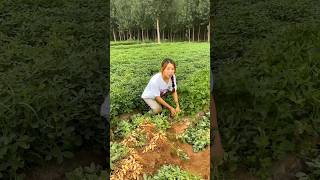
(114, 119, 210, 179)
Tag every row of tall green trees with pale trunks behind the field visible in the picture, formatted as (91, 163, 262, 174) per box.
(110, 0, 210, 43)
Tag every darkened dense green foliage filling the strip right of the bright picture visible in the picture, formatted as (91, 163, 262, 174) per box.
(211, 0, 320, 179)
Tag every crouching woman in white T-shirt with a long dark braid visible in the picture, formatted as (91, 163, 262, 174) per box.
(141, 58, 180, 116)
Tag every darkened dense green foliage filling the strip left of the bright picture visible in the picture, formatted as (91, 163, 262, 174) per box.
(0, 0, 108, 179)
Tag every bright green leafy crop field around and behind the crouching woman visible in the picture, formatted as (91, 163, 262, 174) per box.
(110, 43, 210, 116)
